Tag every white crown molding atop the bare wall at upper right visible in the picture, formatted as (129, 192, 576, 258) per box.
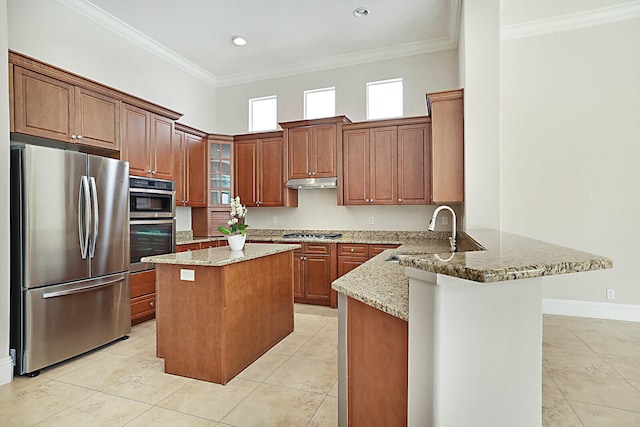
(500, 0, 640, 41)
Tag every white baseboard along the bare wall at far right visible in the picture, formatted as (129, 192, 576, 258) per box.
(542, 298, 640, 322)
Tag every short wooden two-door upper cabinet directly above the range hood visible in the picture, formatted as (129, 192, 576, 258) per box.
(280, 116, 351, 179)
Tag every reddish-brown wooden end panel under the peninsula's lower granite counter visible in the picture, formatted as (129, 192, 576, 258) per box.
(347, 298, 409, 426)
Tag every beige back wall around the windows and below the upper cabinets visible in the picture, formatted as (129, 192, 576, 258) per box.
(212, 50, 462, 230)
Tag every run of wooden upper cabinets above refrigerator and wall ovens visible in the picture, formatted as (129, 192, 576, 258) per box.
(9, 51, 181, 156)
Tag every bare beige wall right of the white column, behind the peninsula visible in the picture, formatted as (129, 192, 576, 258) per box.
(501, 18, 640, 305)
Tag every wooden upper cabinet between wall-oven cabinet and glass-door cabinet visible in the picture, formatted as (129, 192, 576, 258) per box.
(170, 123, 207, 207)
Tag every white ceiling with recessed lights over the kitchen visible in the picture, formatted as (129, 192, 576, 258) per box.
(58, 0, 460, 86)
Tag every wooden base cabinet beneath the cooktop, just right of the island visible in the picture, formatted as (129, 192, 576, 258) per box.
(293, 243, 337, 307)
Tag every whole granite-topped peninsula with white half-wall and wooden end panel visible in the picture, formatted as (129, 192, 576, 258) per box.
(333, 231, 612, 426)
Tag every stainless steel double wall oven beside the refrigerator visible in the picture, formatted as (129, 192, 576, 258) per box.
(129, 176, 176, 272)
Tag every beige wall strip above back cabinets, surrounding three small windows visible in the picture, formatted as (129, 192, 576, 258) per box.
(216, 50, 458, 134)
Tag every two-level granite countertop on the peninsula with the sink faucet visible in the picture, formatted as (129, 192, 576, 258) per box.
(332, 230, 613, 320)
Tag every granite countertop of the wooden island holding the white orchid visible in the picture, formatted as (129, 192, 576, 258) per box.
(141, 243, 300, 267)
